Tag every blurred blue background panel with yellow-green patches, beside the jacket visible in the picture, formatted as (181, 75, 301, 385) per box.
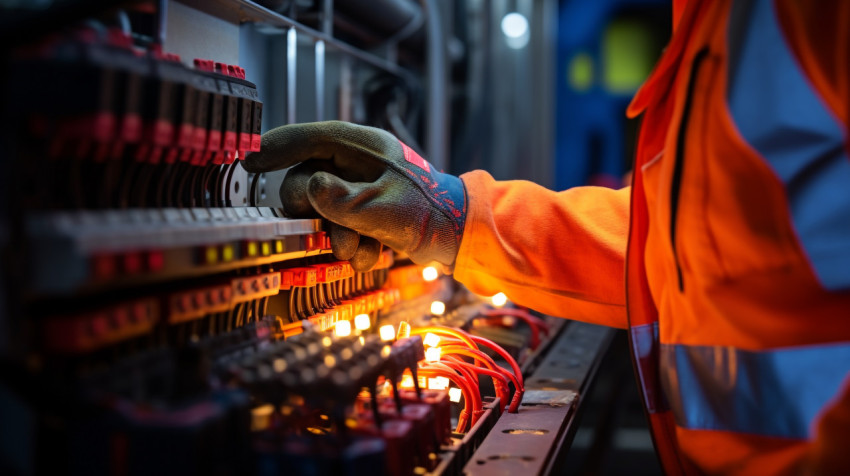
(555, 0, 672, 190)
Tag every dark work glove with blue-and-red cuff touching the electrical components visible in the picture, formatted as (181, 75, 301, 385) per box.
(243, 121, 466, 271)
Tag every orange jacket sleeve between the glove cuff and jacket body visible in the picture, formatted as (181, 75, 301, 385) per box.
(454, 170, 629, 328)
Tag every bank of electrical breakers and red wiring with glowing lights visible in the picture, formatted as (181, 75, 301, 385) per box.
(0, 18, 560, 475)
